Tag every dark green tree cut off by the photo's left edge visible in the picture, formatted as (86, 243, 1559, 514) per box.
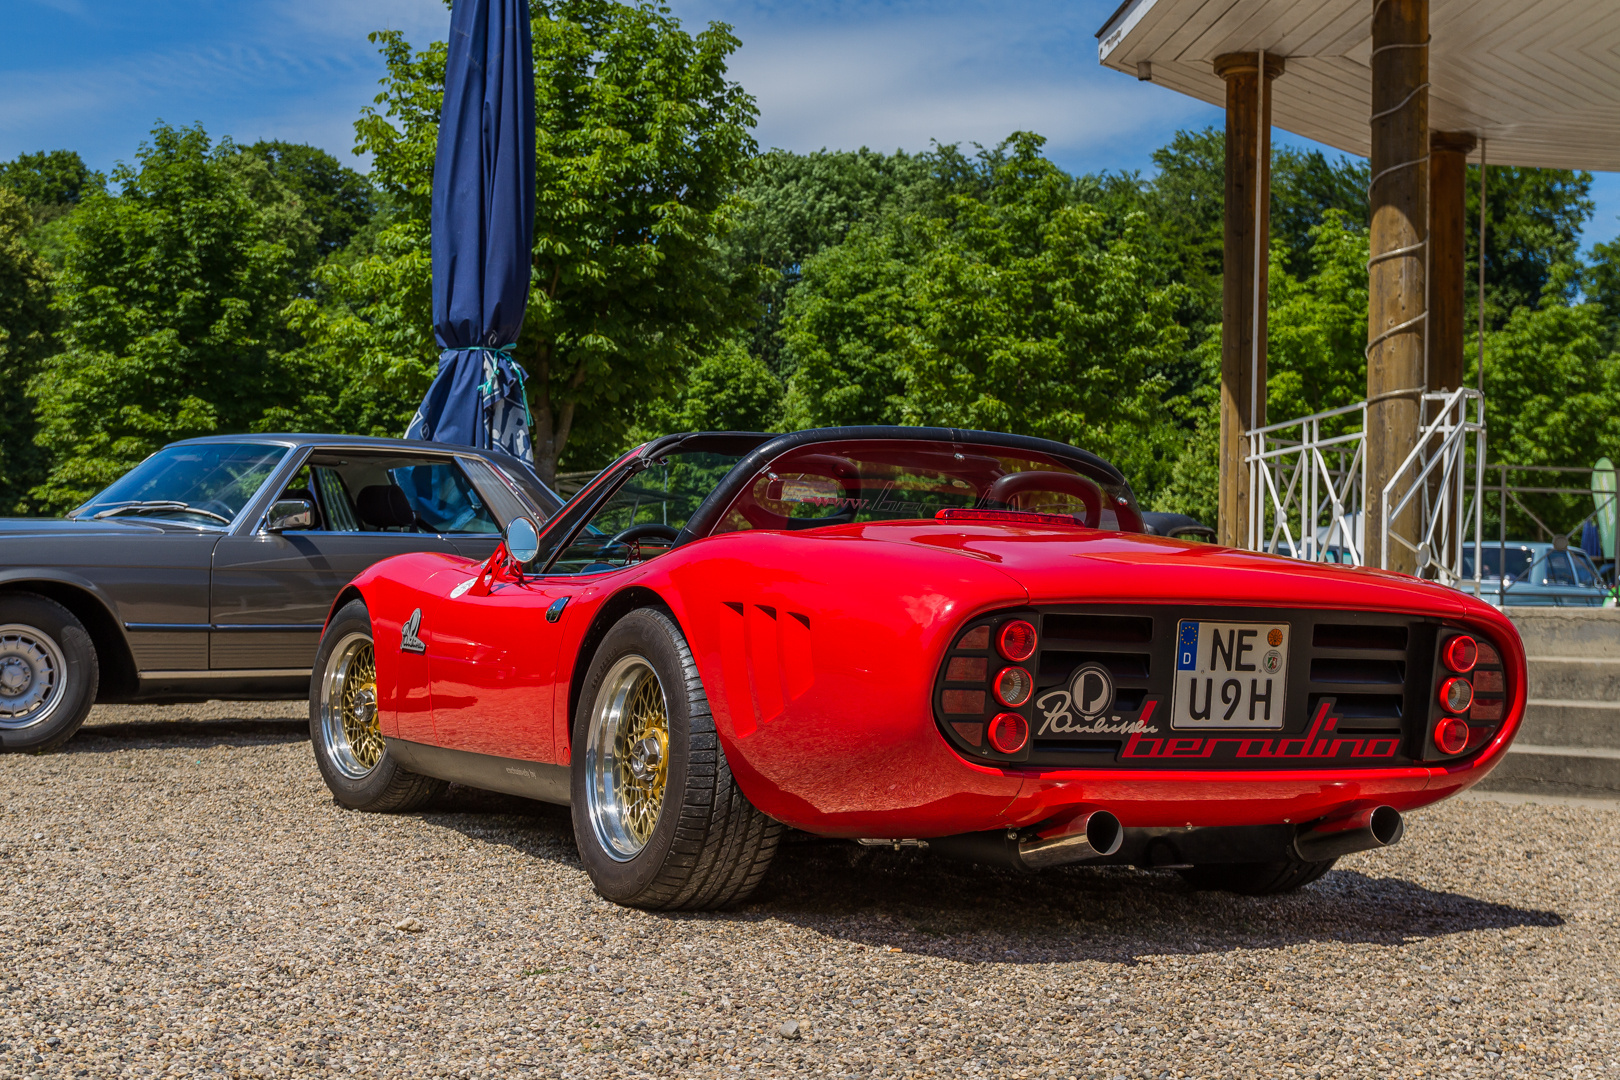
(0, 188, 57, 513)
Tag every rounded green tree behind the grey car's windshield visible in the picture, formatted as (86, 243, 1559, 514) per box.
(34, 125, 314, 508)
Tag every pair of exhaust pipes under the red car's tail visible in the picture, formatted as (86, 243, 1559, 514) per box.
(927, 806, 1406, 870)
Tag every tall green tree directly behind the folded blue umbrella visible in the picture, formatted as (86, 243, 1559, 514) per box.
(295, 0, 761, 478)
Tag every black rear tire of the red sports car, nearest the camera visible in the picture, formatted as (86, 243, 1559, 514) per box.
(572, 607, 782, 910)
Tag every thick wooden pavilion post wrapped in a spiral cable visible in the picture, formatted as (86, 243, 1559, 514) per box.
(1364, 0, 1432, 573)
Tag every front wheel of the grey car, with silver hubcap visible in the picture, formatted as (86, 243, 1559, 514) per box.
(0, 593, 100, 753)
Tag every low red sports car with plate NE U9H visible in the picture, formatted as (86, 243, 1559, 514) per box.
(309, 427, 1524, 908)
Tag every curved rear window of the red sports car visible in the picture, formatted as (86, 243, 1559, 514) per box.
(714, 439, 1142, 533)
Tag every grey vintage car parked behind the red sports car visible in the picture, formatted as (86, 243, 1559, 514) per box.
(0, 436, 562, 750)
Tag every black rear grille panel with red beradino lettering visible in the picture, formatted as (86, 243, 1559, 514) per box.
(935, 606, 1470, 769)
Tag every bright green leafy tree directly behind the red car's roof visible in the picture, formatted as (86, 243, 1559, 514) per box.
(784, 133, 1183, 482)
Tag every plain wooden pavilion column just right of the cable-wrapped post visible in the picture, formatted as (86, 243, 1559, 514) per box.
(1429, 131, 1477, 390)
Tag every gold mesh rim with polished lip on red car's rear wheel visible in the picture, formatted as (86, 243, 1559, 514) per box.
(585, 653, 669, 863)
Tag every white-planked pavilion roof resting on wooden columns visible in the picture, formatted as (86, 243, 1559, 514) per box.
(1097, 0, 1620, 170)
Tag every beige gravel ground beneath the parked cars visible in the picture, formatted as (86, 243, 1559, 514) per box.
(0, 704, 1620, 1080)
